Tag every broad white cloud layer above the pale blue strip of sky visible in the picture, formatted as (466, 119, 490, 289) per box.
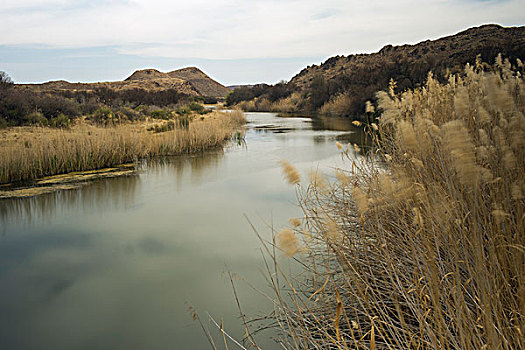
(0, 0, 525, 58)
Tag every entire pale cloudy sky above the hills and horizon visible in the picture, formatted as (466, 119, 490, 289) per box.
(0, 0, 525, 85)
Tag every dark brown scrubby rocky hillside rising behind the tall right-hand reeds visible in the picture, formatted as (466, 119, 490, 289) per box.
(289, 25, 525, 115)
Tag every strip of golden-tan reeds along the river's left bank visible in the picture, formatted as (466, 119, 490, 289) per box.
(0, 111, 245, 183)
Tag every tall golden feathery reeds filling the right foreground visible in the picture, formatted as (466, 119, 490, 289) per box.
(268, 58, 525, 349)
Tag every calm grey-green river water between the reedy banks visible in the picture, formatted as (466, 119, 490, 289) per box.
(0, 113, 363, 350)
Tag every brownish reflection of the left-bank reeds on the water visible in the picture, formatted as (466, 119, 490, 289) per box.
(0, 150, 229, 231)
